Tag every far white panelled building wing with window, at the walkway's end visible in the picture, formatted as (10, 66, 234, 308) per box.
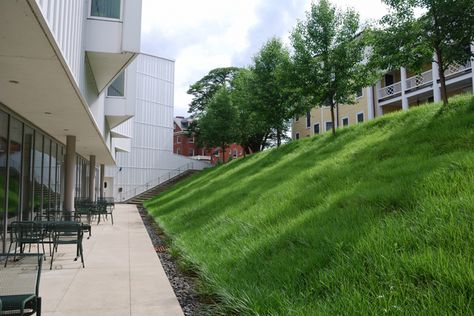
(104, 54, 209, 201)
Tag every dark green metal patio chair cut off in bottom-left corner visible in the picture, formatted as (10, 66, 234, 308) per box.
(0, 254, 43, 315)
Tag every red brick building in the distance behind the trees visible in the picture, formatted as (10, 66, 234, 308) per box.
(173, 116, 244, 164)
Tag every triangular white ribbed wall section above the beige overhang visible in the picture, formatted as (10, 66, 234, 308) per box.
(36, 0, 86, 84)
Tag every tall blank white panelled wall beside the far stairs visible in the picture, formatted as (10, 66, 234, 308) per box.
(106, 55, 207, 199)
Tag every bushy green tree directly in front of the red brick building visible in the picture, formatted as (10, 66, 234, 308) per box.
(197, 87, 237, 162)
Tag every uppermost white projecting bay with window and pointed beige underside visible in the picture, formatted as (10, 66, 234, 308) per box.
(84, 0, 142, 92)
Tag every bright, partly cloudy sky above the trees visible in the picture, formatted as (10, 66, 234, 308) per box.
(142, 0, 386, 116)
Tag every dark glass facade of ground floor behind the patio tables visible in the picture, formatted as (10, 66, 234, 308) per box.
(0, 110, 89, 252)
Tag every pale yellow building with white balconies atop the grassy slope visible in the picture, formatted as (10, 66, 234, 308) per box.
(292, 51, 474, 139)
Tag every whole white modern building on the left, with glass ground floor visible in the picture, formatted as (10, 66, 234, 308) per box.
(0, 0, 206, 252)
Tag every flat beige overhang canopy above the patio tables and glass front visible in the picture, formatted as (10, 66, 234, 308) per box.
(0, 0, 115, 165)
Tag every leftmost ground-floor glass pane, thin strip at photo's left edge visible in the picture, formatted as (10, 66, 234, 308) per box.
(0, 111, 8, 252)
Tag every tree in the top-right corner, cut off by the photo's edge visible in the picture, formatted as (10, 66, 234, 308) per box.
(373, 0, 474, 105)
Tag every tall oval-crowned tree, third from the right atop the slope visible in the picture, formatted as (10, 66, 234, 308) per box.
(251, 38, 301, 146)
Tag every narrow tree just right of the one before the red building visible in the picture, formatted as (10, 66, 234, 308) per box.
(231, 69, 271, 153)
